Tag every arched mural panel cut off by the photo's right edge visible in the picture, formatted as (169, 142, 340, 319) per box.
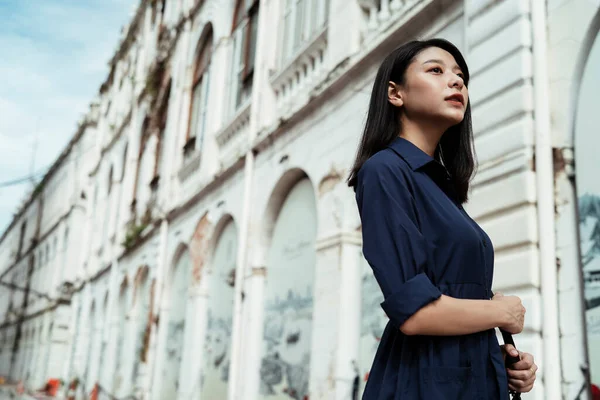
(575, 25, 600, 394)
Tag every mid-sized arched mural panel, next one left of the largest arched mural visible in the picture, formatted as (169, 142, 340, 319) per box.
(200, 221, 237, 399)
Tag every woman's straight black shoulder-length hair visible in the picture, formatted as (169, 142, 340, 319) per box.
(347, 39, 475, 203)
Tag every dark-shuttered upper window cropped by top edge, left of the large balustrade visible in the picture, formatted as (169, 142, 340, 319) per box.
(231, 0, 259, 111)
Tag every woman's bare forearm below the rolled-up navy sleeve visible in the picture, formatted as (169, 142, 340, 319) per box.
(400, 295, 506, 336)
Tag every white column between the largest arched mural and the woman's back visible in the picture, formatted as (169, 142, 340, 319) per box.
(310, 231, 362, 400)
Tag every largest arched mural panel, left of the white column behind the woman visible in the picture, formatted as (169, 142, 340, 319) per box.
(260, 179, 317, 400)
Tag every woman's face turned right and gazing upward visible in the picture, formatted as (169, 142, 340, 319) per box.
(390, 47, 469, 127)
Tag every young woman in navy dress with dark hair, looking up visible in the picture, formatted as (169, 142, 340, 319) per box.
(348, 39, 537, 400)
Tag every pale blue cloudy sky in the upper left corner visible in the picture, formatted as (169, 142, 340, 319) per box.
(0, 0, 139, 232)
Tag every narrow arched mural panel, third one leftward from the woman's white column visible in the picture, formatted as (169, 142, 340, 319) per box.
(160, 249, 191, 399)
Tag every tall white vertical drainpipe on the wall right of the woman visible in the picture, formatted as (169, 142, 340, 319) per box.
(530, 0, 562, 400)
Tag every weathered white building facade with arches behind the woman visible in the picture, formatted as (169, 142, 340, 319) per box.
(0, 0, 600, 400)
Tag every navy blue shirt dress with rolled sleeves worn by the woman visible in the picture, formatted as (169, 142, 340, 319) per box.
(356, 138, 508, 400)
